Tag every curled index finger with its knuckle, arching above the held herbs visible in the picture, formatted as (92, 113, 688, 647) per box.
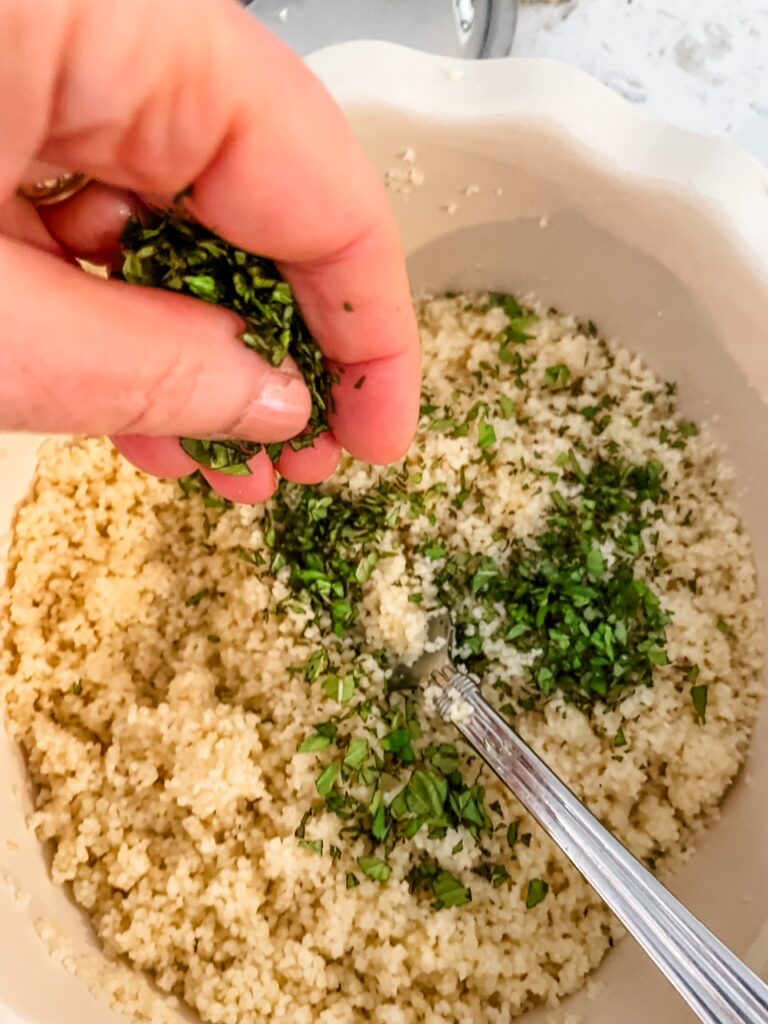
(10, 0, 419, 462)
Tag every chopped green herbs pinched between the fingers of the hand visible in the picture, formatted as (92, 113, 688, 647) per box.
(122, 216, 333, 476)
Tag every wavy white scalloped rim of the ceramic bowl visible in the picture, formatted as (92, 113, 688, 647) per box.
(306, 40, 768, 287)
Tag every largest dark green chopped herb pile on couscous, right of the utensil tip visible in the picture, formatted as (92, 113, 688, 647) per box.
(436, 451, 669, 708)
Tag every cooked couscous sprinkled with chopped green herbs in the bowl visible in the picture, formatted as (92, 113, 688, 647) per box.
(3, 295, 762, 1024)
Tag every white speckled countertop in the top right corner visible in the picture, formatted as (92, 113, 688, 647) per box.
(512, 0, 768, 164)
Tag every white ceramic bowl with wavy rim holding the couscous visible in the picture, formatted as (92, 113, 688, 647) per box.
(0, 44, 768, 1024)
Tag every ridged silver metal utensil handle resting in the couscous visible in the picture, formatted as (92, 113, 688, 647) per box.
(433, 668, 768, 1024)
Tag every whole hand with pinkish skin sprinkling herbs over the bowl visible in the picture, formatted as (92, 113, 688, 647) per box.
(0, 0, 420, 503)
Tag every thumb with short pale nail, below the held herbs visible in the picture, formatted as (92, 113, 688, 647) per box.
(0, 238, 310, 443)
